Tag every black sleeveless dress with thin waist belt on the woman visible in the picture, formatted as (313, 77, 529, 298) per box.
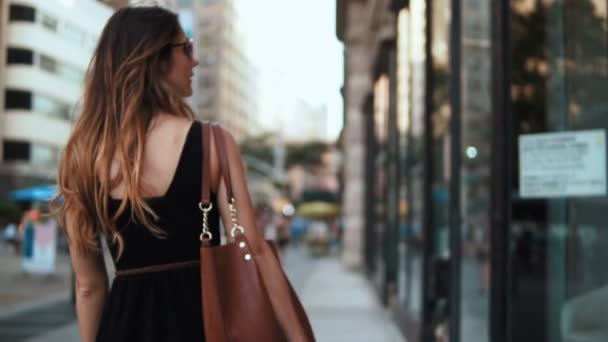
(97, 121, 219, 342)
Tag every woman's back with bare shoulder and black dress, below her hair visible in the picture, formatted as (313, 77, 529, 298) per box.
(98, 118, 219, 341)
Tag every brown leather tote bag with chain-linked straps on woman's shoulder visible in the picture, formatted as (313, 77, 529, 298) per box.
(199, 124, 315, 342)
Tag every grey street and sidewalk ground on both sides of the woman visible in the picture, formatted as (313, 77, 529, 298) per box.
(0, 243, 404, 342)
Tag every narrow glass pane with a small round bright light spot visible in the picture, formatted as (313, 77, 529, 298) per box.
(459, 0, 492, 342)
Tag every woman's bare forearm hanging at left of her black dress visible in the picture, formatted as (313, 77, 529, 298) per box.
(70, 235, 108, 342)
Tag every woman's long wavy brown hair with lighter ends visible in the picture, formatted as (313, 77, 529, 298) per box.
(51, 7, 194, 255)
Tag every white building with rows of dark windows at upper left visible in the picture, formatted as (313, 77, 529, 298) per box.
(0, 0, 113, 192)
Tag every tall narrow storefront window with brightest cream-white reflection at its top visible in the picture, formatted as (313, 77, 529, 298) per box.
(397, 0, 427, 322)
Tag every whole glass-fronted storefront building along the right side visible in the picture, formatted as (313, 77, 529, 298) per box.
(336, 0, 608, 342)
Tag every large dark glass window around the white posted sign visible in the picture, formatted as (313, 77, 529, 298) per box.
(508, 0, 608, 342)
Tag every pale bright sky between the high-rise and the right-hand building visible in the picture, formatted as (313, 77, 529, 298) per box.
(236, 0, 344, 139)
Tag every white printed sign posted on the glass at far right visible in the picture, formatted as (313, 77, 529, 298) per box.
(519, 130, 606, 198)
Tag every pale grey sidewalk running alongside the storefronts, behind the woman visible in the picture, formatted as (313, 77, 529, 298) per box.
(15, 248, 405, 342)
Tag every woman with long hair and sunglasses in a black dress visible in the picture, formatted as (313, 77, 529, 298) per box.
(53, 7, 255, 342)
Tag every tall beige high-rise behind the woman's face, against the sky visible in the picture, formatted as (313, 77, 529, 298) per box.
(177, 0, 258, 141)
